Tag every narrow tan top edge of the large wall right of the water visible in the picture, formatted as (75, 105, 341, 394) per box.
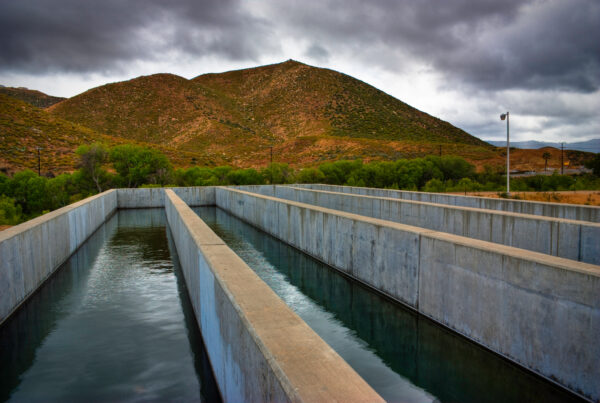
(221, 186, 600, 277)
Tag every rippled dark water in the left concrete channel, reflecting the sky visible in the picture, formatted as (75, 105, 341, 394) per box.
(0, 209, 219, 402)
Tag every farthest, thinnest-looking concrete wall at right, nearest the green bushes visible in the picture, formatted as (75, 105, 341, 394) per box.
(294, 185, 600, 222)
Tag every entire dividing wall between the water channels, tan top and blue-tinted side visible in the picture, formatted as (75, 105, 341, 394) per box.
(165, 190, 383, 402)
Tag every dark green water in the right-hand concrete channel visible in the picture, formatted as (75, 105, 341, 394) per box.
(194, 207, 580, 402)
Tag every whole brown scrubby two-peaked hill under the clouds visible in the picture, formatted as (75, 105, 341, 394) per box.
(48, 61, 496, 166)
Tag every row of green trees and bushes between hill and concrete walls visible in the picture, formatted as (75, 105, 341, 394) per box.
(0, 143, 600, 225)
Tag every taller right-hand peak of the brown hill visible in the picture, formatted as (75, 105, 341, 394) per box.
(193, 60, 487, 146)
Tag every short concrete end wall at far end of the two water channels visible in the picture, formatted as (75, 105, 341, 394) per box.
(117, 186, 215, 208)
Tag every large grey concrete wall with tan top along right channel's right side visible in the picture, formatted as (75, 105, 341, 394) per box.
(215, 188, 600, 400)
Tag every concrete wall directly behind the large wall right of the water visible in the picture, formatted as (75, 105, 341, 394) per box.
(238, 186, 600, 265)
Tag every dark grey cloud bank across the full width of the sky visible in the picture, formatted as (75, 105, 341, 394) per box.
(0, 0, 600, 92)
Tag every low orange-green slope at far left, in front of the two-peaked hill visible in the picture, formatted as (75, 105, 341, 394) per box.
(0, 94, 221, 174)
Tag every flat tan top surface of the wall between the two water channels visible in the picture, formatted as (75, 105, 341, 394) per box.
(165, 189, 384, 402)
